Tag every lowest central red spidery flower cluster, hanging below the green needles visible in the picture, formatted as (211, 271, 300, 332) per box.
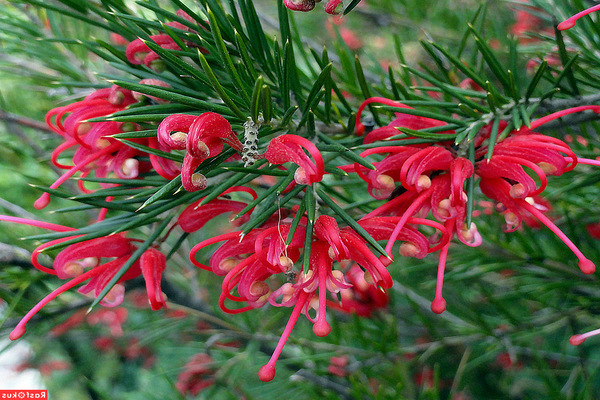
(190, 202, 449, 381)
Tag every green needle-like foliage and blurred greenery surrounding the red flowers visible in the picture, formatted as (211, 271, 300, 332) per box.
(0, 0, 600, 399)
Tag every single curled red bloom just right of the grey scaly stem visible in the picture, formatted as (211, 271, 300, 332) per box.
(265, 135, 325, 185)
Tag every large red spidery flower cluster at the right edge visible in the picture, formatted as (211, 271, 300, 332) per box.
(352, 98, 600, 313)
